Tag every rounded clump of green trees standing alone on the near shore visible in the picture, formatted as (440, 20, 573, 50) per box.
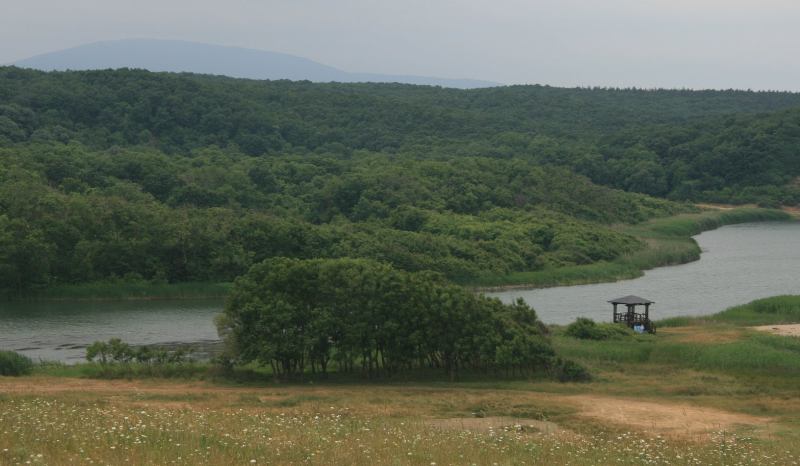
(218, 258, 587, 379)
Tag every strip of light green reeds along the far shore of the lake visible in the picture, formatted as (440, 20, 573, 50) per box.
(7, 208, 800, 302)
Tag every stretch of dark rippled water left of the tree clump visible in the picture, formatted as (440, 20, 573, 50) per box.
(0, 300, 223, 362)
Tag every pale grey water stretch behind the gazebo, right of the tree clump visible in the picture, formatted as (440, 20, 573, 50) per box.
(487, 222, 800, 324)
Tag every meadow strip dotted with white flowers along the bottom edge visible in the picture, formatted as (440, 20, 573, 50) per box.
(0, 395, 800, 465)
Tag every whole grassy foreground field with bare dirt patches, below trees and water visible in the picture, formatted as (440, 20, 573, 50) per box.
(0, 296, 800, 465)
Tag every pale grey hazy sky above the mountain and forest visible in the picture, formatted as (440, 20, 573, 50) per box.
(0, 0, 800, 91)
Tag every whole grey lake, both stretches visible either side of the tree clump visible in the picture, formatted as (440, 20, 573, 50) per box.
(0, 223, 800, 362)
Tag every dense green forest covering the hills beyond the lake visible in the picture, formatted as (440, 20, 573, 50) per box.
(0, 67, 800, 292)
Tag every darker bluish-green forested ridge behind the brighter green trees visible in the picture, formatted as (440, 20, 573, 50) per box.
(0, 67, 800, 204)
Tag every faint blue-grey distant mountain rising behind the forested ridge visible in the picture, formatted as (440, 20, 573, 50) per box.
(13, 39, 499, 89)
